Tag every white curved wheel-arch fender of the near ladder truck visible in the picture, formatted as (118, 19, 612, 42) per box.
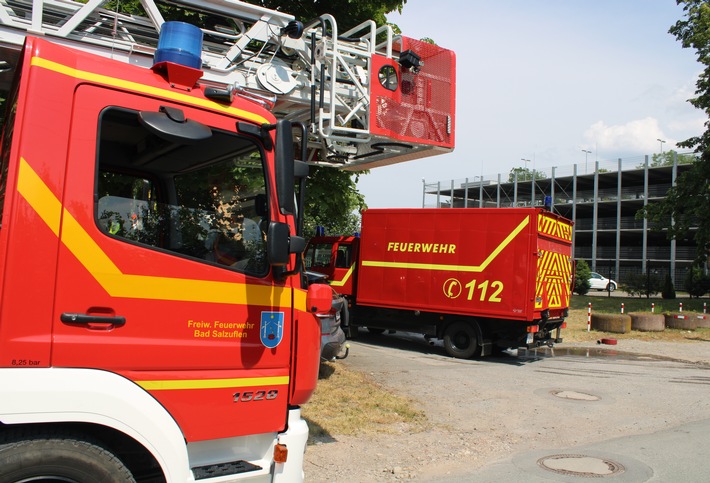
(0, 368, 191, 481)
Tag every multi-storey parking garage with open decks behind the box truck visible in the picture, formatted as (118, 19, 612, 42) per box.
(422, 153, 697, 288)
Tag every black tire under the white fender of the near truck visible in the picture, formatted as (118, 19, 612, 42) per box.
(0, 432, 135, 483)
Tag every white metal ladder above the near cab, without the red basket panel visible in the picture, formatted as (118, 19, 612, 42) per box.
(0, 0, 453, 169)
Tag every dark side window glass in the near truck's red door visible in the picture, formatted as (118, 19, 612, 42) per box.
(96, 109, 268, 276)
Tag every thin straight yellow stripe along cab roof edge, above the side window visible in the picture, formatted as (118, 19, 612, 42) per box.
(31, 57, 269, 124)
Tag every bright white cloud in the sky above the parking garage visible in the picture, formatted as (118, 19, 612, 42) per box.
(584, 117, 675, 153)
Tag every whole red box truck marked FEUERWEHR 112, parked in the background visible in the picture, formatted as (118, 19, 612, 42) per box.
(305, 208, 572, 358)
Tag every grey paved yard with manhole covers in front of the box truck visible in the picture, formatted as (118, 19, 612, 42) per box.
(344, 333, 710, 483)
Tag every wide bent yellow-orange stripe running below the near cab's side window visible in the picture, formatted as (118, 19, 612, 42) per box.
(17, 158, 306, 312)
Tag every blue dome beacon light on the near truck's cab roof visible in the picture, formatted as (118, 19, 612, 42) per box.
(153, 22, 202, 69)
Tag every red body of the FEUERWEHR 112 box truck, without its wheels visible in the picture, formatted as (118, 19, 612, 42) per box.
(307, 208, 572, 321)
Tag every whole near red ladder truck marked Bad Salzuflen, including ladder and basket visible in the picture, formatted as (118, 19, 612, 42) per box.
(0, 0, 453, 483)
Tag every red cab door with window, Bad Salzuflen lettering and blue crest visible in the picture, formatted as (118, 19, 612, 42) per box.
(50, 85, 292, 441)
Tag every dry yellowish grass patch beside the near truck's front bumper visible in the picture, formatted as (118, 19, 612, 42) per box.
(302, 362, 427, 443)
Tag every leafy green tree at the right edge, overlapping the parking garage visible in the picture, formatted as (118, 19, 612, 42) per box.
(642, 0, 710, 262)
